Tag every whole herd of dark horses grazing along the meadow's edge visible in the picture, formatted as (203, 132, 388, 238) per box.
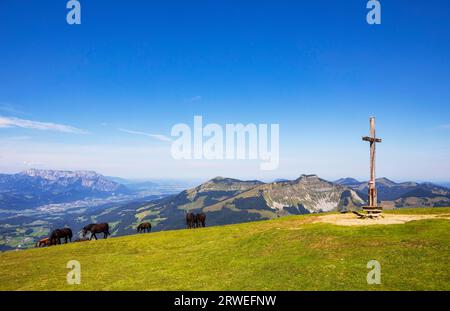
(36, 213, 206, 247)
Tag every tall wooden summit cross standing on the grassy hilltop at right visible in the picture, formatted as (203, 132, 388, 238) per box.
(362, 117, 383, 214)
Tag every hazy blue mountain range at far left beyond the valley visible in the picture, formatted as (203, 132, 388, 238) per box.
(0, 169, 191, 210)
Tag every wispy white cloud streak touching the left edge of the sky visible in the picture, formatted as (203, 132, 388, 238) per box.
(0, 116, 88, 134)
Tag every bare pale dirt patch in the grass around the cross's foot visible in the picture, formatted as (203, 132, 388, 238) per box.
(314, 213, 450, 226)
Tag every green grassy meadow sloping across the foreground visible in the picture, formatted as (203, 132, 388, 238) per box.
(0, 208, 450, 290)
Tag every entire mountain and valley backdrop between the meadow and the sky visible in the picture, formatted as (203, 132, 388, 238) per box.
(0, 170, 450, 250)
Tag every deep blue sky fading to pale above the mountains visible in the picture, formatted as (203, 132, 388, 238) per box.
(0, 0, 450, 181)
